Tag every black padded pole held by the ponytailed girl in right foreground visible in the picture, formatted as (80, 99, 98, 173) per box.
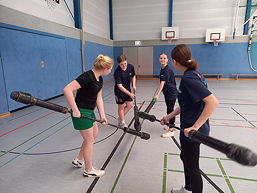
(138, 112, 257, 166)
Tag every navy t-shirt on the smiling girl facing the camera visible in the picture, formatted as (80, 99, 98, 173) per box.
(160, 65, 178, 100)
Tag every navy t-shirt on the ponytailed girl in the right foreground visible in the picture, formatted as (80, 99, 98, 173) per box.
(178, 70, 212, 142)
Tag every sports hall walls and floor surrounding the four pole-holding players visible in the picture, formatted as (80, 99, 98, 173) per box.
(0, 0, 257, 193)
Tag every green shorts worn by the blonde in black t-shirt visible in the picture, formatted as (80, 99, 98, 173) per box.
(71, 108, 96, 130)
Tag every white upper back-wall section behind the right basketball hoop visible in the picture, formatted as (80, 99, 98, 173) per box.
(172, 0, 246, 38)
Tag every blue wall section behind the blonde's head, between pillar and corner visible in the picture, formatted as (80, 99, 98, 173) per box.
(84, 42, 113, 80)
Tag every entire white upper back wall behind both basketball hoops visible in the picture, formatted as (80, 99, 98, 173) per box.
(113, 0, 246, 41)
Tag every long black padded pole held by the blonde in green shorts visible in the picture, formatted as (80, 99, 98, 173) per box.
(10, 91, 150, 140)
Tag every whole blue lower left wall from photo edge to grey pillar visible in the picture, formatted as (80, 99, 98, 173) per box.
(0, 23, 82, 113)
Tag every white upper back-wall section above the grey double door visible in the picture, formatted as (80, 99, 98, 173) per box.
(113, 0, 169, 40)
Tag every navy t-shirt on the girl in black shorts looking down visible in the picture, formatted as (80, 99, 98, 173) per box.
(114, 64, 135, 97)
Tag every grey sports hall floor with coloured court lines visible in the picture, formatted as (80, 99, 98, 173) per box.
(0, 79, 257, 193)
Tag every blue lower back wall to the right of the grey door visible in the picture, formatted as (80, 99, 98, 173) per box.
(153, 43, 249, 78)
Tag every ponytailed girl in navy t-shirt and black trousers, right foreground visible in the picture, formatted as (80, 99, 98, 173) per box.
(161, 44, 218, 193)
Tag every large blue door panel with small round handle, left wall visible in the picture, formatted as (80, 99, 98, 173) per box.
(0, 28, 68, 110)
